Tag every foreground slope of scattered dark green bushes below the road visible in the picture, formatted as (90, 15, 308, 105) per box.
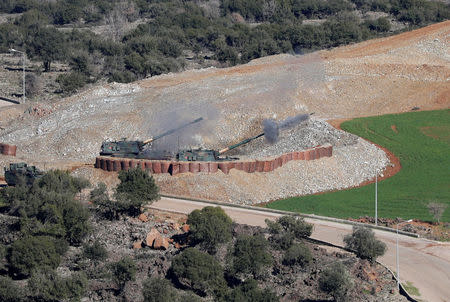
(0, 168, 398, 302)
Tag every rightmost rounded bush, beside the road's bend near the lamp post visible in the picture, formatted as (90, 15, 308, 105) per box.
(344, 226, 386, 261)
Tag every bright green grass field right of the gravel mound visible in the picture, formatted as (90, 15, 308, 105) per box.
(267, 110, 450, 222)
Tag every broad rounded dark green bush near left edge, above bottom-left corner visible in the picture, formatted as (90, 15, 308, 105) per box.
(7, 236, 66, 277)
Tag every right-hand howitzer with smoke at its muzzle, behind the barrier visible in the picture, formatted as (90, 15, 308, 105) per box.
(177, 132, 264, 161)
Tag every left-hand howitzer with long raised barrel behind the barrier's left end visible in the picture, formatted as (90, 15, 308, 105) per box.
(100, 117, 203, 158)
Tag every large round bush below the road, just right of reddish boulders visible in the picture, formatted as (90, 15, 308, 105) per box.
(187, 206, 232, 253)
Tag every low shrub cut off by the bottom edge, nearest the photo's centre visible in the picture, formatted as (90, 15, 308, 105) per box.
(226, 279, 280, 302)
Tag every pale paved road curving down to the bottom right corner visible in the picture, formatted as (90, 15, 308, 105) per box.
(150, 197, 450, 302)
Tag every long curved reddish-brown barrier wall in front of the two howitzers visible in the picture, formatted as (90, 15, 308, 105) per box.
(95, 144, 333, 175)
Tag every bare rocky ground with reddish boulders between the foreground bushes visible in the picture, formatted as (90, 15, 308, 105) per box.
(0, 211, 406, 302)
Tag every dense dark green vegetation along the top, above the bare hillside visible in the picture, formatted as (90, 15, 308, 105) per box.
(0, 0, 450, 93)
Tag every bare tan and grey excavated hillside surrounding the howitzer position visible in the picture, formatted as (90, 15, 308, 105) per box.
(0, 21, 450, 203)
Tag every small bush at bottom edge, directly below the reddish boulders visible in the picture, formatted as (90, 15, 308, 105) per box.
(142, 278, 177, 302)
